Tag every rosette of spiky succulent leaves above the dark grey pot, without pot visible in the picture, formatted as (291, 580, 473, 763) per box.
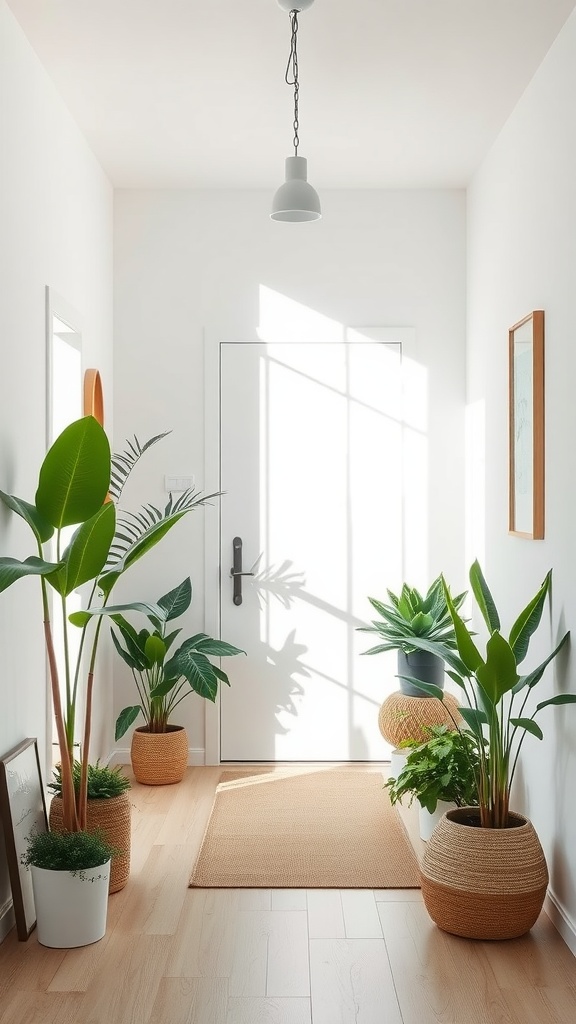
(359, 577, 466, 654)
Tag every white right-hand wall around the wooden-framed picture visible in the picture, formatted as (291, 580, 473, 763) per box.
(468, 6, 576, 951)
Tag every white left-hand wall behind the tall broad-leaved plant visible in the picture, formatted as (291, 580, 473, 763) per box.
(0, 0, 113, 929)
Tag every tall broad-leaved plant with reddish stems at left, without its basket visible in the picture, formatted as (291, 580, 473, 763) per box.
(0, 416, 214, 833)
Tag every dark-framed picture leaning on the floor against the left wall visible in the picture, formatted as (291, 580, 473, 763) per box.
(0, 739, 48, 942)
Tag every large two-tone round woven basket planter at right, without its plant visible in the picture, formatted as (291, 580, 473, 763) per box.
(421, 807, 548, 939)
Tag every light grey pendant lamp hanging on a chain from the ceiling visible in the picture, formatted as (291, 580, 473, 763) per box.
(271, 0, 322, 221)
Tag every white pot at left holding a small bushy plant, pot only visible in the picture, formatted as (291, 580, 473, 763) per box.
(31, 860, 110, 949)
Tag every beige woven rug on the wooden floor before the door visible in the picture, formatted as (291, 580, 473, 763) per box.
(190, 768, 420, 889)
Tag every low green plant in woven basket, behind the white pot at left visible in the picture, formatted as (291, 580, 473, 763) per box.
(47, 761, 131, 893)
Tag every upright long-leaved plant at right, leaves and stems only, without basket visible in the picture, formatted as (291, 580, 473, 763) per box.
(399, 561, 576, 828)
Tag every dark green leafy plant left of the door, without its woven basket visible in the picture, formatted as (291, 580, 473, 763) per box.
(72, 577, 245, 739)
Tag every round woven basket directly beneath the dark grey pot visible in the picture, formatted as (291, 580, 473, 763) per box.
(378, 692, 460, 746)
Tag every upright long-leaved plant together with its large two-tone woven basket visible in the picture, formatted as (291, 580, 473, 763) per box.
(403, 561, 576, 939)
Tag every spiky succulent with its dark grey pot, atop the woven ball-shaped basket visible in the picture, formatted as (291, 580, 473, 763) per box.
(359, 577, 466, 697)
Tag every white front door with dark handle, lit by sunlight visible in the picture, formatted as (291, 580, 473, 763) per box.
(220, 343, 404, 761)
